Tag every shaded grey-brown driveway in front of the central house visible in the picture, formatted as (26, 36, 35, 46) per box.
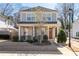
(0, 40, 62, 54)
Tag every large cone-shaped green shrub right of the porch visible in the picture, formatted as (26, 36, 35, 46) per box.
(57, 29, 67, 43)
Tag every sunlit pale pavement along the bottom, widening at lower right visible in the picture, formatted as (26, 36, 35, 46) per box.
(0, 47, 75, 56)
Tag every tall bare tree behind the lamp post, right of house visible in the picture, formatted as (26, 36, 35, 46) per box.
(57, 3, 74, 36)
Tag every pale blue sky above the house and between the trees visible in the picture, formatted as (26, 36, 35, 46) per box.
(0, 3, 79, 18)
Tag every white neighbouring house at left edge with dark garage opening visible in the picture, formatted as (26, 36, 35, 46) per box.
(0, 14, 16, 38)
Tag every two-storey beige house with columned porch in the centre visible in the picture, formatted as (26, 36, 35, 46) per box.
(17, 6, 57, 40)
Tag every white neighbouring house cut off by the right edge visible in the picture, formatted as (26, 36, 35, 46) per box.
(71, 20, 79, 38)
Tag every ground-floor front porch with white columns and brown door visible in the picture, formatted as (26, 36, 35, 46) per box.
(18, 25, 57, 40)
